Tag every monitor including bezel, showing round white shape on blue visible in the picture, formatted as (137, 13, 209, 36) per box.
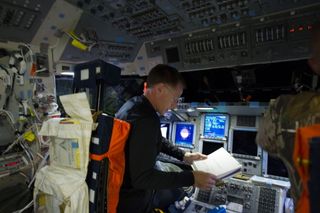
(173, 122, 196, 148)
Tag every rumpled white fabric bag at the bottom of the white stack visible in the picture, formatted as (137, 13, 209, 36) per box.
(34, 166, 89, 213)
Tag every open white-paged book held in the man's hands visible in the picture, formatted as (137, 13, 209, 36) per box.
(191, 147, 241, 179)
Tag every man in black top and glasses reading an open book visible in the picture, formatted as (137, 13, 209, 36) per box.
(116, 64, 216, 213)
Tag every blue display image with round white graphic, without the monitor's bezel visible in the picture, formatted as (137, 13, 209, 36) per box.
(175, 123, 194, 148)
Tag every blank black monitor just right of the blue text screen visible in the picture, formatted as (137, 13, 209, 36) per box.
(232, 129, 258, 156)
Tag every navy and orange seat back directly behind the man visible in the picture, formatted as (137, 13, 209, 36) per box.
(86, 114, 130, 213)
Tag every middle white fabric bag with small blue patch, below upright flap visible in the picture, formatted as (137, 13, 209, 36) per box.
(39, 118, 92, 174)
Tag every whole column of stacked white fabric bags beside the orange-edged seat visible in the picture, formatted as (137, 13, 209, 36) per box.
(34, 93, 94, 213)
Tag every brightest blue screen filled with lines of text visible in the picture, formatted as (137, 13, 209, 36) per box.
(203, 115, 227, 141)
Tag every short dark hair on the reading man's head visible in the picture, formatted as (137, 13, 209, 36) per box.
(147, 64, 185, 88)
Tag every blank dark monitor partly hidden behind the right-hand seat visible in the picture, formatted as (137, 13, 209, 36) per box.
(267, 154, 289, 178)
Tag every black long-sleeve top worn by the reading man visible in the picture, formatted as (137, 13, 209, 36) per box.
(116, 96, 194, 213)
